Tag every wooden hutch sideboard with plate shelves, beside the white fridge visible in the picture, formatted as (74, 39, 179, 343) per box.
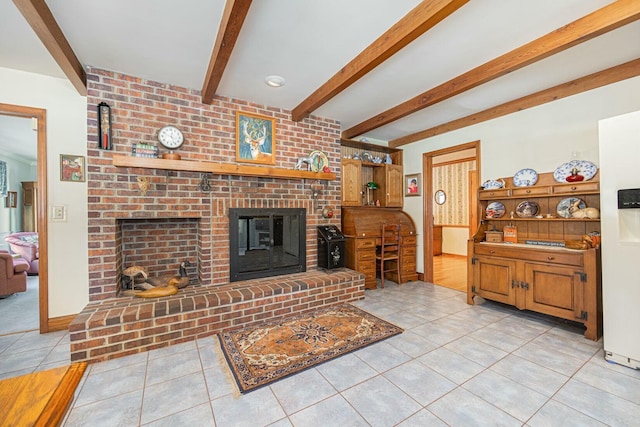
(467, 173, 602, 340)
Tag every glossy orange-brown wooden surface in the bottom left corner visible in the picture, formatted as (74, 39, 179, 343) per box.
(0, 362, 87, 427)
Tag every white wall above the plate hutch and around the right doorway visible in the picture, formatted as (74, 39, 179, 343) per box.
(401, 77, 640, 272)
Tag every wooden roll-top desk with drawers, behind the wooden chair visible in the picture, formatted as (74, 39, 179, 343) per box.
(342, 207, 418, 289)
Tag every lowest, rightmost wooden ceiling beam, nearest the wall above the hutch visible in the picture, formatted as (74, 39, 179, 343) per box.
(389, 59, 640, 148)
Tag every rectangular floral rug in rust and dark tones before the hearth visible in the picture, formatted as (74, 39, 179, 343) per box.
(219, 304, 403, 393)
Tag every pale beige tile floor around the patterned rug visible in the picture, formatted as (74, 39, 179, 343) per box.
(0, 281, 640, 427)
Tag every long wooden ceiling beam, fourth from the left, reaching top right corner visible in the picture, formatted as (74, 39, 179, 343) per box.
(341, 0, 640, 139)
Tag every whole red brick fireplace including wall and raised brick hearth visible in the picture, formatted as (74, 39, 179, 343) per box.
(69, 68, 364, 362)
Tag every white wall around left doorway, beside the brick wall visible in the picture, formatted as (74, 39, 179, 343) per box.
(0, 67, 89, 317)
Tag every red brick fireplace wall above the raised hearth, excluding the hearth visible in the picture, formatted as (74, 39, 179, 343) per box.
(87, 69, 340, 301)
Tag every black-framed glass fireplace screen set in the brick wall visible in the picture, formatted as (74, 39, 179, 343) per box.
(229, 208, 307, 282)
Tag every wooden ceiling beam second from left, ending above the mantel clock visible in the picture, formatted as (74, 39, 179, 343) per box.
(202, 0, 251, 104)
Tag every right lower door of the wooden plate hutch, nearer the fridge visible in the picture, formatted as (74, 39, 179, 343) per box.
(525, 263, 584, 320)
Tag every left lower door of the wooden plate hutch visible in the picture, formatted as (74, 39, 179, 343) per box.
(473, 257, 516, 305)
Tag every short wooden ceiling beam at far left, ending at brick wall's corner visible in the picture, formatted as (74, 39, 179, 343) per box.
(13, 0, 87, 96)
